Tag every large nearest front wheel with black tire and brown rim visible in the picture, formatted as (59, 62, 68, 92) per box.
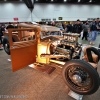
(63, 60, 100, 95)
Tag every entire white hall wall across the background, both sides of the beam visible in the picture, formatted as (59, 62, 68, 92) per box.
(0, 2, 100, 22)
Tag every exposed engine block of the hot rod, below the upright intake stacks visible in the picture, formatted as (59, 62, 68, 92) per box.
(50, 39, 81, 60)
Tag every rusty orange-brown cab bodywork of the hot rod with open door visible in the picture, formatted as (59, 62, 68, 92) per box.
(8, 23, 78, 71)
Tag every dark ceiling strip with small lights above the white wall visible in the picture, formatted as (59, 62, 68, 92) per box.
(0, 0, 100, 4)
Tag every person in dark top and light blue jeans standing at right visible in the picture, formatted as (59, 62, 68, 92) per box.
(90, 19, 98, 44)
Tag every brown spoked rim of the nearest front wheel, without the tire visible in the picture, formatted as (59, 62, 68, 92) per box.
(65, 65, 93, 91)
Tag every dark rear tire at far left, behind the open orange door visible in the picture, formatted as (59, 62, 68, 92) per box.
(3, 36, 10, 55)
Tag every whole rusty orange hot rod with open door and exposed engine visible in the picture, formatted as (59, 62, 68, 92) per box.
(3, 23, 100, 95)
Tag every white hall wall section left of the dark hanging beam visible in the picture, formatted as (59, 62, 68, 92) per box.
(0, 3, 31, 22)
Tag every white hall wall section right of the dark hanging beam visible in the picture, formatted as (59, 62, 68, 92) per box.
(33, 4, 100, 21)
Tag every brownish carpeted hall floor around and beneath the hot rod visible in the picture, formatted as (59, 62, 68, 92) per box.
(0, 34, 100, 100)
